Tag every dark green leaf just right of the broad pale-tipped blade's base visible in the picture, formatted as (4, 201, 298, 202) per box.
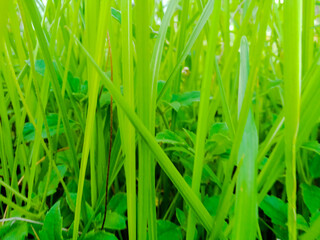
(260, 195, 288, 226)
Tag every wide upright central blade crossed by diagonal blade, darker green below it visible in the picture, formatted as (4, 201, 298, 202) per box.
(136, 0, 157, 237)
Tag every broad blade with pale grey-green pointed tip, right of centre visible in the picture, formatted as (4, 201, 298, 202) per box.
(233, 37, 258, 239)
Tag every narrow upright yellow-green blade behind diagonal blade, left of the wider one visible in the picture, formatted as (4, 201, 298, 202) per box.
(119, 0, 137, 240)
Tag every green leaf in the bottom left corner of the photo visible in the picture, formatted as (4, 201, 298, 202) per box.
(0, 222, 28, 240)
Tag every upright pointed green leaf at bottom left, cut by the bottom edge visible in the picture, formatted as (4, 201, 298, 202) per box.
(39, 201, 63, 240)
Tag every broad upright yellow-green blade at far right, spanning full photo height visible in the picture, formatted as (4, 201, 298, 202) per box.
(283, 0, 302, 240)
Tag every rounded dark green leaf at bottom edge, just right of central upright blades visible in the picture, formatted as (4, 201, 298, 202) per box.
(157, 220, 182, 240)
